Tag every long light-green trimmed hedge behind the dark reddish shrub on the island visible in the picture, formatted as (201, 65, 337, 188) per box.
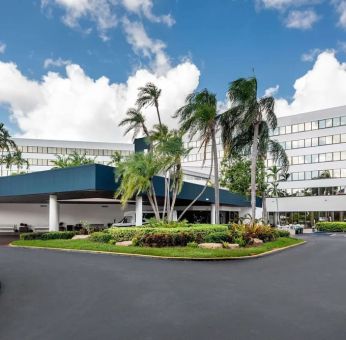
(105, 225, 228, 243)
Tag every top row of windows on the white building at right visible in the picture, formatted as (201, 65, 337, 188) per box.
(270, 116, 346, 136)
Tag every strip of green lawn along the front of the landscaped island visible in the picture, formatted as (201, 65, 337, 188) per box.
(11, 237, 303, 258)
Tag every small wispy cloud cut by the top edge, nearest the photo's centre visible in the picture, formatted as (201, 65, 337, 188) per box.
(122, 0, 175, 26)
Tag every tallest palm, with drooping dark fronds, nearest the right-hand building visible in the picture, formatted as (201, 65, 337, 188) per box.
(223, 77, 277, 224)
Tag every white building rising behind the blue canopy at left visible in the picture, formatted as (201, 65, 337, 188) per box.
(0, 138, 134, 176)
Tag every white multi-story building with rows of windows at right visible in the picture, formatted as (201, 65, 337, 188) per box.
(267, 106, 346, 227)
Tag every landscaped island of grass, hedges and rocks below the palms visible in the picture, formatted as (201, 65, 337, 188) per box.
(12, 221, 303, 259)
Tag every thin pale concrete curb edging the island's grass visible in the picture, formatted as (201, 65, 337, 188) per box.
(9, 241, 306, 261)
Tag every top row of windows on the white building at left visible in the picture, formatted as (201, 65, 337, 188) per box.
(14, 146, 131, 156)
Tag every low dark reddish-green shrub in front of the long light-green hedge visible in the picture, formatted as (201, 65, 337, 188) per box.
(133, 232, 193, 247)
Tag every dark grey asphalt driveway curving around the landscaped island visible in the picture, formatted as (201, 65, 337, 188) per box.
(0, 235, 346, 340)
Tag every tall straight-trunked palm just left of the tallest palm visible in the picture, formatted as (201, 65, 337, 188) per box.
(174, 89, 220, 224)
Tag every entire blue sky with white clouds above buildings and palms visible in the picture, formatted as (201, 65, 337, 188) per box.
(0, 0, 346, 142)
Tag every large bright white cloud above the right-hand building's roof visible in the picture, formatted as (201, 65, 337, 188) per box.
(276, 51, 346, 116)
